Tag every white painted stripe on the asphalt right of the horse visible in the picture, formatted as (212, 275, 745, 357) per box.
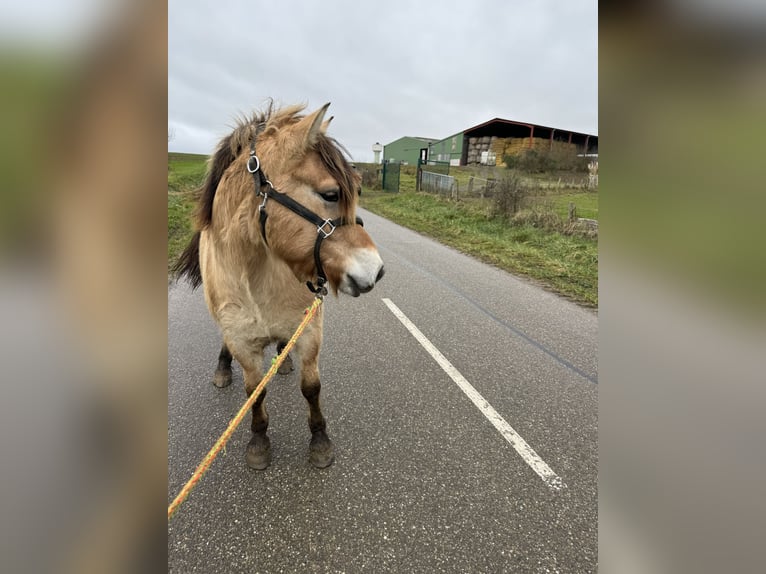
(383, 298, 566, 490)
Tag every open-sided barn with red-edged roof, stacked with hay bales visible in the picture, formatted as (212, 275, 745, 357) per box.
(428, 118, 598, 165)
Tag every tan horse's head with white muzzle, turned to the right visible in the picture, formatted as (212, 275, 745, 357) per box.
(256, 103, 383, 297)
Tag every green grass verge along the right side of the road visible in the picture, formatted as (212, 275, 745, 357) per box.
(361, 189, 598, 307)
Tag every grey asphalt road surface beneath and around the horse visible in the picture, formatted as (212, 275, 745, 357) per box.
(168, 211, 598, 574)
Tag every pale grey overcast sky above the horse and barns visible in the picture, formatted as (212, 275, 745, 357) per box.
(168, 0, 598, 162)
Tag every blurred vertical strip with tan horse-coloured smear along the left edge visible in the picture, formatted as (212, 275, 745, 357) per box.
(0, 0, 167, 572)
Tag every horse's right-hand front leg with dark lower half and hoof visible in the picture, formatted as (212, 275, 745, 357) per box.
(297, 327, 335, 468)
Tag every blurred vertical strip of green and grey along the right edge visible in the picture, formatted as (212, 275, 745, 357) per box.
(599, 1, 766, 572)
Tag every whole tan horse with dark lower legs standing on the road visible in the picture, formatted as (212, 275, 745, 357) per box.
(174, 103, 384, 470)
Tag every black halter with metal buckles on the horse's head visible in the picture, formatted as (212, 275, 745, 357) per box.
(247, 140, 364, 297)
